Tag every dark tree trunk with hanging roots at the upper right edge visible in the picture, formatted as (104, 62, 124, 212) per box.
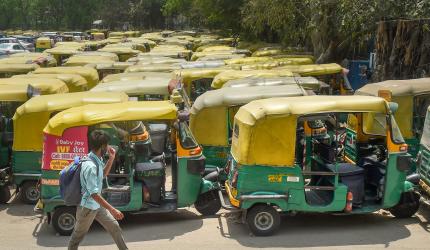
(373, 19, 430, 81)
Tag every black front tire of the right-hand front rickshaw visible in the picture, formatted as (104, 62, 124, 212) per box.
(388, 192, 420, 218)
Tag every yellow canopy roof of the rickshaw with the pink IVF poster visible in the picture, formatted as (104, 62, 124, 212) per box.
(43, 101, 177, 136)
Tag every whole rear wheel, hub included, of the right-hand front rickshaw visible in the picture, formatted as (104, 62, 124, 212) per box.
(246, 204, 281, 236)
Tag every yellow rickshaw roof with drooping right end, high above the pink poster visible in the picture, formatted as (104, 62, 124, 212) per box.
(33, 66, 99, 89)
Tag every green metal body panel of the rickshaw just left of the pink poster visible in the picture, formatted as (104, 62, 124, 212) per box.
(12, 151, 42, 185)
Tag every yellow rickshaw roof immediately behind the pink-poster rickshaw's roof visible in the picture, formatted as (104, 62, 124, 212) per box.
(90, 78, 170, 101)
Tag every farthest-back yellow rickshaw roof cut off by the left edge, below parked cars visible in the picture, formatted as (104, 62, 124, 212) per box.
(0, 53, 57, 67)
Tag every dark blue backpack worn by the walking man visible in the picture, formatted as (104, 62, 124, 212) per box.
(60, 157, 99, 206)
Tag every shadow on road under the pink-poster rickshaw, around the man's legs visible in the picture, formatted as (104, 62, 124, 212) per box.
(33, 210, 203, 247)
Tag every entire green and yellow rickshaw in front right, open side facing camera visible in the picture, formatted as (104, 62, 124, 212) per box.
(223, 96, 420, 236)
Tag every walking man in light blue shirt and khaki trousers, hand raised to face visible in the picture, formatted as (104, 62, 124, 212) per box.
(69, 130, 128, 250)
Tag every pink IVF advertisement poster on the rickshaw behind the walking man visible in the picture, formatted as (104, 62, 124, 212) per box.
(42, 126, 88, 170)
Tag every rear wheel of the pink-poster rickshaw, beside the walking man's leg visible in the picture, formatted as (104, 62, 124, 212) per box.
(52, 207, 76, 236)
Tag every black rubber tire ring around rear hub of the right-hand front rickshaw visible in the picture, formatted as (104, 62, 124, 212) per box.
(246, 204, 281, 236)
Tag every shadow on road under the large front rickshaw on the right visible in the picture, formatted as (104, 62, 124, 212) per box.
(220, 211, 420, 248)
